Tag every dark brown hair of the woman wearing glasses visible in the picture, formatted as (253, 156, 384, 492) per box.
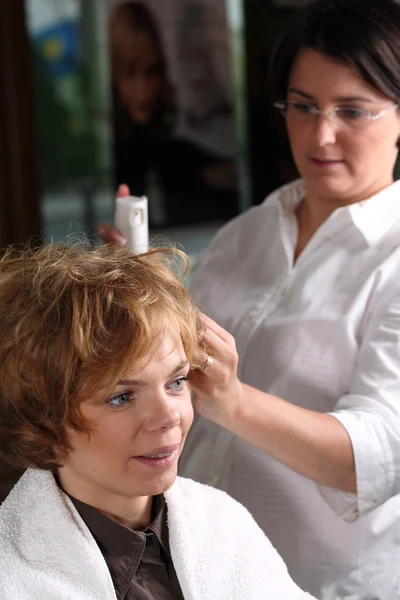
(269, 0, 400, 104)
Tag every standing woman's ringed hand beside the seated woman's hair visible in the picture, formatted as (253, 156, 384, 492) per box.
(191, 315, 243, 427)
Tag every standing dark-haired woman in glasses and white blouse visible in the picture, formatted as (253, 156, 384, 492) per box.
(99, 0, 400, 600)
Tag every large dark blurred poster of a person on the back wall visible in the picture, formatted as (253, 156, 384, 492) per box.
(108, 0, 238, 228)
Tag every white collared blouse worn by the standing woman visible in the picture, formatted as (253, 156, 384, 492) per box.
(181, 181, 400, 600)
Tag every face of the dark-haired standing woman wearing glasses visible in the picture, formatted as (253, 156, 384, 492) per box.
(286, 50, 400, 203)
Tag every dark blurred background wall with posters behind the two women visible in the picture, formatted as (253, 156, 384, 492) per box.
(0, 0, 310, 256)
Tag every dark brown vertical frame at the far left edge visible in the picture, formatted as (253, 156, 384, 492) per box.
(0, 0, 41, 248)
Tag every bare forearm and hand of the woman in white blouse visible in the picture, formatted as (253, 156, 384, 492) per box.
(192, 317, 357, 493)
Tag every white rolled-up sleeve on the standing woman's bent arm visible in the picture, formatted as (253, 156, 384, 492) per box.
(319, 285, 400, 522)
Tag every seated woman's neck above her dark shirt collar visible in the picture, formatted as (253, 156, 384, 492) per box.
(54, 468, 153, 530)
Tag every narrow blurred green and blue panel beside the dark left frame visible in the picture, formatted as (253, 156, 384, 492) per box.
(26, 0, 94, 192)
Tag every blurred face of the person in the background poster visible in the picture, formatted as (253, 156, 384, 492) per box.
(111, 21, 161, 124)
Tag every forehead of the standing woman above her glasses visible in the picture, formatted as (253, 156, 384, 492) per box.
(289, 49, 386, 101)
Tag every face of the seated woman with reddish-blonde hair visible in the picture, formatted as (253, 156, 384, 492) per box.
(59, 333, 193, 505)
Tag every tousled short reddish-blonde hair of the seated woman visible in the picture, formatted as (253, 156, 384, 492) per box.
(0, 244, 202, 470)
